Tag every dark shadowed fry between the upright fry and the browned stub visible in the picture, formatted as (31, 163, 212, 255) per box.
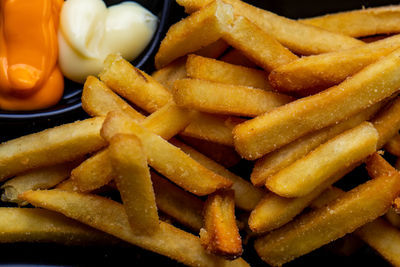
(151, 172, 204, 232)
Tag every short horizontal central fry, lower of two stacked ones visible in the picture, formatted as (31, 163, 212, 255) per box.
(173, 79, 293, 117)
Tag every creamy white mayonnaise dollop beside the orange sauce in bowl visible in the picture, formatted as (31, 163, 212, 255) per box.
(58, 0, 157, 83)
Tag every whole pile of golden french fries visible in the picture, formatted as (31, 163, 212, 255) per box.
(0, 0, 400, 266)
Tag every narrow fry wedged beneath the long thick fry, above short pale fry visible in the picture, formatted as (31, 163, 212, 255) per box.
(250, 102, 383, 186)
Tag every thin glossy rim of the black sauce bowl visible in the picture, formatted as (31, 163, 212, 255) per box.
(0, 0, 172, 121)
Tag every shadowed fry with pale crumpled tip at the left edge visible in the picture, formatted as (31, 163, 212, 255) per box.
(0, 162, 77, 206)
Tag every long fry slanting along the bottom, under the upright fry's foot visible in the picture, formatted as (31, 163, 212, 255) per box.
(21, 190, 249, 266)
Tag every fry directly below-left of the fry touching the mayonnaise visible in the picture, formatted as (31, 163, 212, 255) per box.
(82, 76, 145, 122)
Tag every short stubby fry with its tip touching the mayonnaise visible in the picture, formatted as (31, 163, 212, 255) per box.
(99, 54, 172, 112)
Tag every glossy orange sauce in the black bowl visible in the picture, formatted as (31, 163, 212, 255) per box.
(0, 0, 64, 110)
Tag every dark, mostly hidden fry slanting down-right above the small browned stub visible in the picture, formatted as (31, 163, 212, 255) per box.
(170, 139, 262, 211)
